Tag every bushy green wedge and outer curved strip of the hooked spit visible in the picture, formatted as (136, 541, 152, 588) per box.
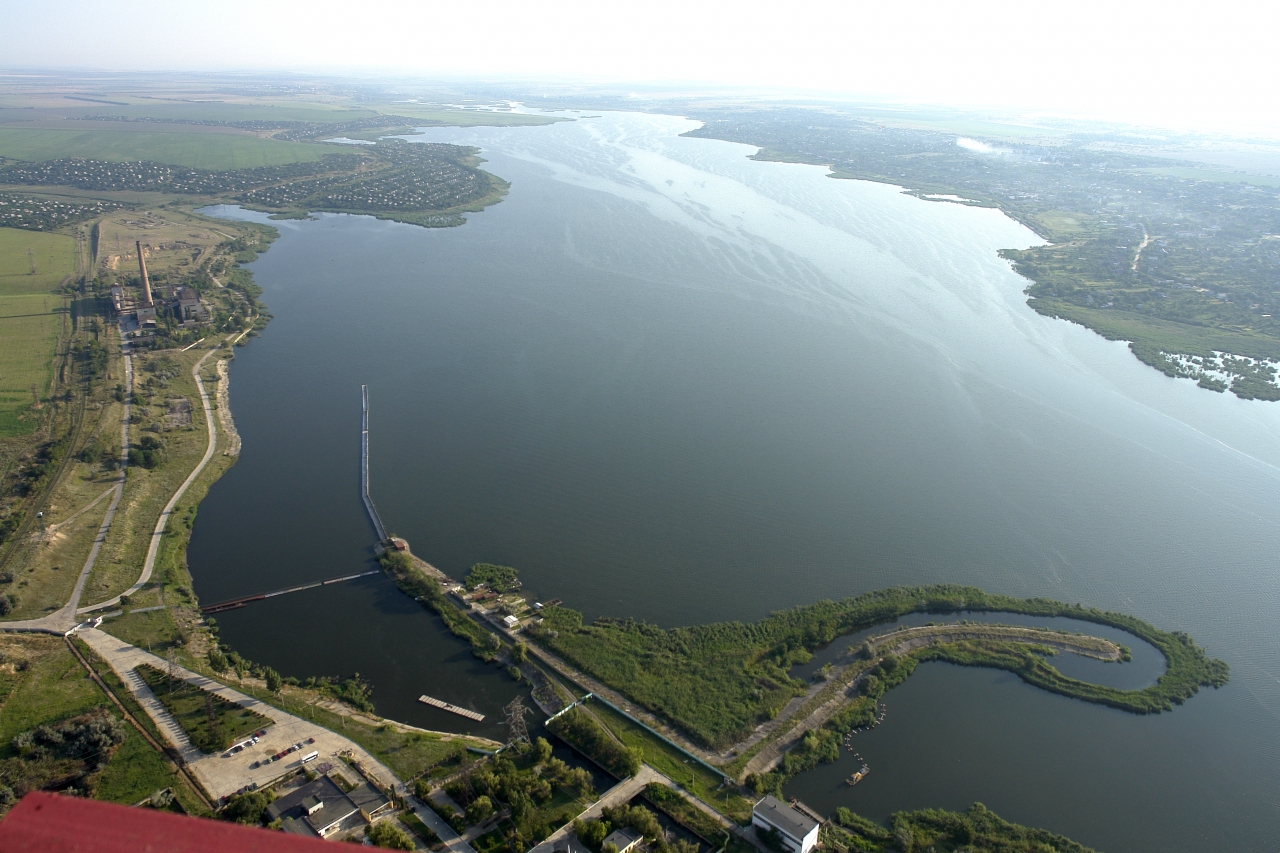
(530, 585, 1229, 748)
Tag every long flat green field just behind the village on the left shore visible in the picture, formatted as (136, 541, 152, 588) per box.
(0, 128, 325, 170)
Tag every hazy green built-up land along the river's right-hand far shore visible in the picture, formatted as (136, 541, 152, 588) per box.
(686, 105, 1280, 401)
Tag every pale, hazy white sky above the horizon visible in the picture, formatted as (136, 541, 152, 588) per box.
(0, 0, 1280, 137)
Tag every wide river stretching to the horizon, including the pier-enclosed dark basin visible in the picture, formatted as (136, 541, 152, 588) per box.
(189, 113, 1280, 853)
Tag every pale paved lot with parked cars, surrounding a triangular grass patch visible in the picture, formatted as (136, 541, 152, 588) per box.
(78, 628, 396, 799)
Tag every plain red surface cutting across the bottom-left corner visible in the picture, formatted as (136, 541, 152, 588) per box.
(0, 792, 335, 853)
